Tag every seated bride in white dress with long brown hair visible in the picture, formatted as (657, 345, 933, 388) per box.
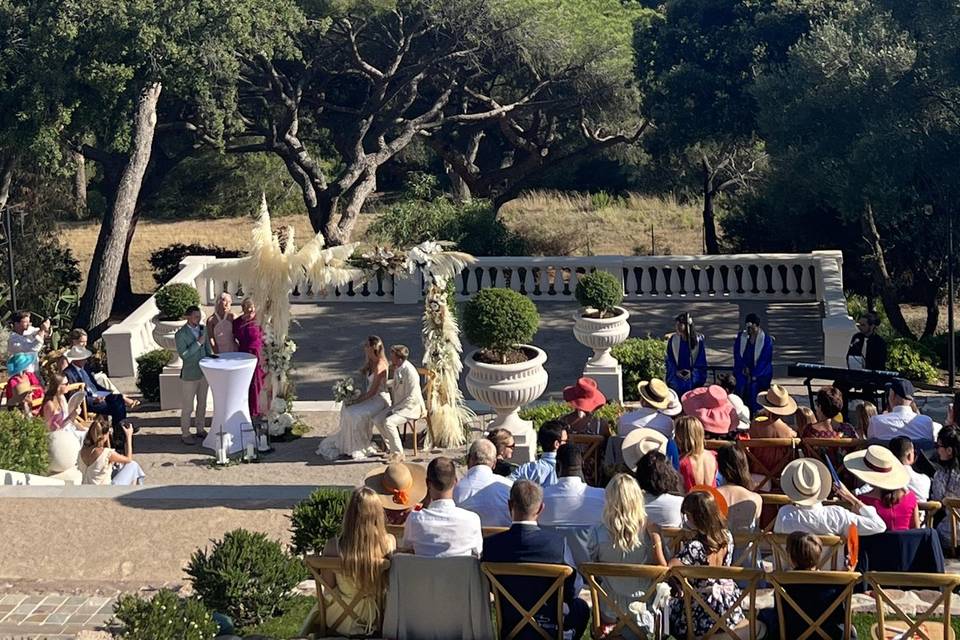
(317, 336, 390, 460)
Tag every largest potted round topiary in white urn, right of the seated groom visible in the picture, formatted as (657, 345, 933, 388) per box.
(463, 289, 547, 460)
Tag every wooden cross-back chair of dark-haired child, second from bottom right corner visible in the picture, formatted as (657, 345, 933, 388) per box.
(767, 571, 866, 640)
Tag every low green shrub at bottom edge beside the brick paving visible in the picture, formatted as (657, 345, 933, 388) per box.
(113, 589, 218, 640)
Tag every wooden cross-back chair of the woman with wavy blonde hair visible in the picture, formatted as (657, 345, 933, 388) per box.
(577, 562, 670, 638)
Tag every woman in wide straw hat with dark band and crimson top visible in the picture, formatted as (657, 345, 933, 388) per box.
(843, 444, 920, 531)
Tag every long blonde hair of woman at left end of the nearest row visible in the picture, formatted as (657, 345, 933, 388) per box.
(338, 487, 393, 594)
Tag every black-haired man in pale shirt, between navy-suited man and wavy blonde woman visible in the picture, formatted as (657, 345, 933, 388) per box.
(540, 444, 603, 527)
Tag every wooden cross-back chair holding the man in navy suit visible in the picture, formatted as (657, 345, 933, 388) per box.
(480, 562, 573, 640)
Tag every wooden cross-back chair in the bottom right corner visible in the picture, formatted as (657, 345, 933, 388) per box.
(866, 571, 960, 640)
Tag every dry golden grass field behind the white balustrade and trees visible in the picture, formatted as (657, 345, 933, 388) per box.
(60, 191, 702, 292)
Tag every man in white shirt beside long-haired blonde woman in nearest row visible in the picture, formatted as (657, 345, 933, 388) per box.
(401, 458, 483, 558)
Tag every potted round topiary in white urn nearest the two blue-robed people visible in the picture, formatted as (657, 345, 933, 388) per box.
(573, 271, 630, 367)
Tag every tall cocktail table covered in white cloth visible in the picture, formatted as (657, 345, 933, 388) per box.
(200, 353, 257, 455)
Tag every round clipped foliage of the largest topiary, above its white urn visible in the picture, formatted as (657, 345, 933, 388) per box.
(463, 289, 540, 358)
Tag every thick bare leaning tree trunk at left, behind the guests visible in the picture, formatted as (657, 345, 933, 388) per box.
(76, 82, 161, 339)
